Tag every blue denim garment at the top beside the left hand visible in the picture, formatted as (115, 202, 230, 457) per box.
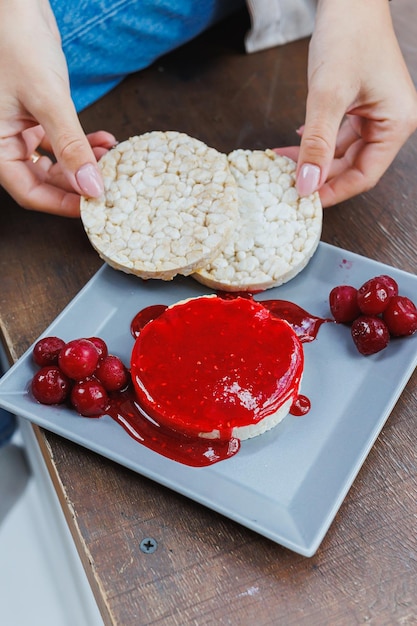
(51, 0, 245, 111)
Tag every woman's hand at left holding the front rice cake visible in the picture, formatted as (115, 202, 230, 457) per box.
(0, 0, 116, 217)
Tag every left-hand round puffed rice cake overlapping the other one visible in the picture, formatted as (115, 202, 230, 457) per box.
(81, 131, 238, 280)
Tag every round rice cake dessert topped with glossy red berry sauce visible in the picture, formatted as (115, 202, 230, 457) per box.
(131, 295, 304, 440)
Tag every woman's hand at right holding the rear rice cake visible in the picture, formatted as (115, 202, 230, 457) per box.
(277, 0, 417, 206)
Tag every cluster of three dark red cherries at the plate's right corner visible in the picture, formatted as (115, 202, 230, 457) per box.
(329, 274, 417, 355)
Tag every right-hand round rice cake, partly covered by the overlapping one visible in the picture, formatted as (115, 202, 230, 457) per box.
(193, 149, 322, 291)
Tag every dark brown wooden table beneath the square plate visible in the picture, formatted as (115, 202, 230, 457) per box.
(0, 6, 417, 626)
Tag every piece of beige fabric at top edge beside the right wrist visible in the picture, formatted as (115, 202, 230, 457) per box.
(245, 0, 317, 52)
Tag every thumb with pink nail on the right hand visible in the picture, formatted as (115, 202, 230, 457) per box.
(296, 91, 345, 196)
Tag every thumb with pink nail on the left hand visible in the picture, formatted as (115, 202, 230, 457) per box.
(38, 99, 104, 198)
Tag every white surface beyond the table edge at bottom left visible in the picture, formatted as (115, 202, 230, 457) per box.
(0, 422, 103, 626)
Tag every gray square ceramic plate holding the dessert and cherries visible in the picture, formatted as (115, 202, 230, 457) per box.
(0, 243, 417, 556)
